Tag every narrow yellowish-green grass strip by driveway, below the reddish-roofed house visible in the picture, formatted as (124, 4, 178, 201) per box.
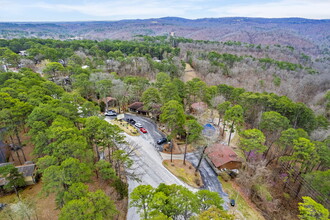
(219, 177, 265, 220)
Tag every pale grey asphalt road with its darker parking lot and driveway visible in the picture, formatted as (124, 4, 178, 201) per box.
(106, 114, 229, 220)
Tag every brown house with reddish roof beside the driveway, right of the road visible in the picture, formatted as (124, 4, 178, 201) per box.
(205, 143, 242, 170)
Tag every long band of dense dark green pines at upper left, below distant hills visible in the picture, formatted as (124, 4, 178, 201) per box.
(0, 38, 180, 61)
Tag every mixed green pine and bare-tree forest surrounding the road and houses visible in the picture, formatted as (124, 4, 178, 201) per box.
(0, 35, 330, 219)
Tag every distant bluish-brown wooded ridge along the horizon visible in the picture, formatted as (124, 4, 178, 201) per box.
(0, 17, 330, 55)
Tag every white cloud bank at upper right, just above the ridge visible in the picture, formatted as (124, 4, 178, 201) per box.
(210, 0, 330, 19)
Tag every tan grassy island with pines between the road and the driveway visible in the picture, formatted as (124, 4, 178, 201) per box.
(163, 160, 203, 188)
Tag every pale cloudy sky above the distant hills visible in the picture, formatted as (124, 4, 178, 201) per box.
(0, 0, 330, 22)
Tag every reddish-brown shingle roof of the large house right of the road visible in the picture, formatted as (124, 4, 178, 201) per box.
(205, 143, 241, 167)
